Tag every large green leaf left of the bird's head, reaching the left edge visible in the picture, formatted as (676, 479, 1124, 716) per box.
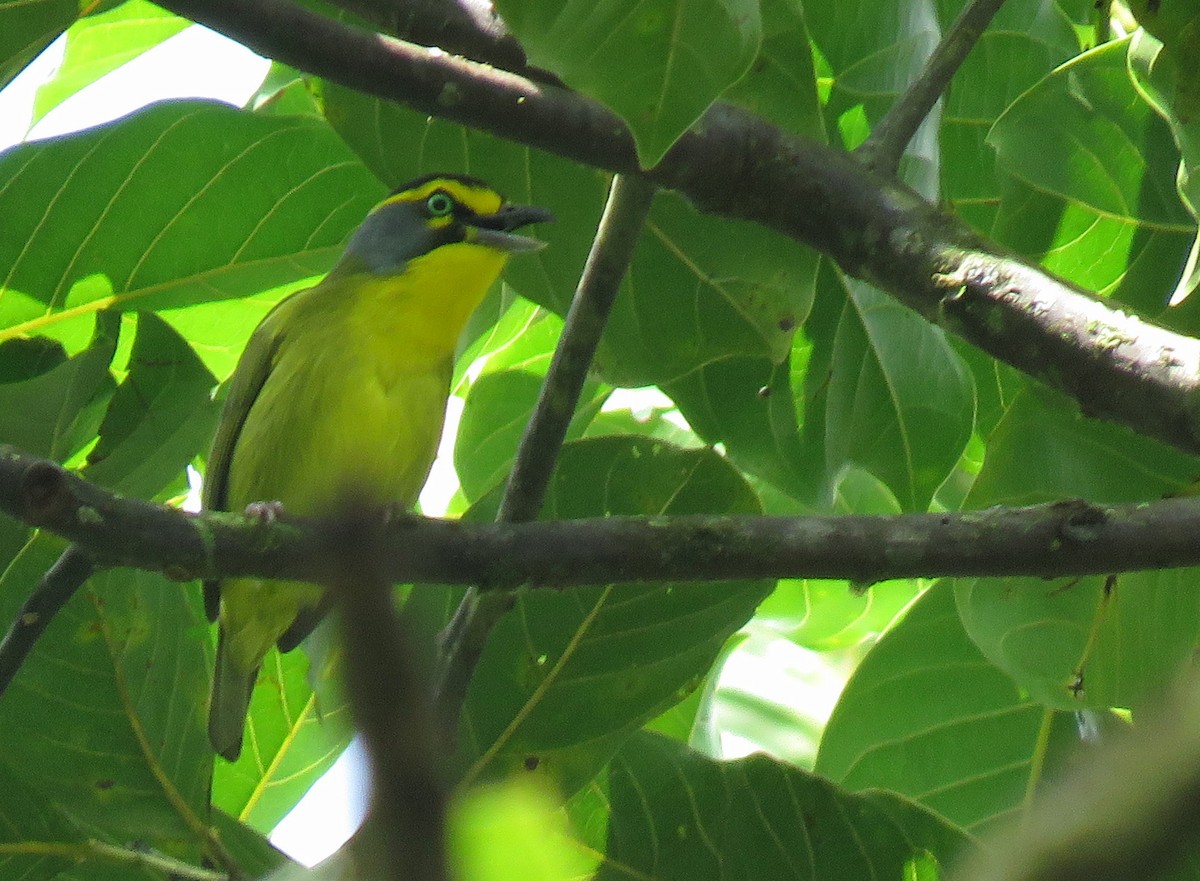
(0, 101, 383, 376)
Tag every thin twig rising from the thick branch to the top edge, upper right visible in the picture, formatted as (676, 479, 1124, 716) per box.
(856, 0, 1004, 175)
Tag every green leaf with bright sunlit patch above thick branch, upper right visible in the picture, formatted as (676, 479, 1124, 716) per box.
(988, 41, 1196, 312)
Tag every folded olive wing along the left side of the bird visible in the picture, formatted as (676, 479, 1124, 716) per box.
(200, 298, 290, 621)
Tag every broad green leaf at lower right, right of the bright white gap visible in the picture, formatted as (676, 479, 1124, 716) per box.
(816, 582, 1076, 832)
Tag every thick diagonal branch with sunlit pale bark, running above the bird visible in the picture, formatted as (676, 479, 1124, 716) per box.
(152, 0, 1200, 453)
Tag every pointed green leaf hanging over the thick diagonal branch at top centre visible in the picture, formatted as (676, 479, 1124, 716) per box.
(496, 0, 762, 168)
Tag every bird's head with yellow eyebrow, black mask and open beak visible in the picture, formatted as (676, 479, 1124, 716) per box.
(335, 174, 553, 275)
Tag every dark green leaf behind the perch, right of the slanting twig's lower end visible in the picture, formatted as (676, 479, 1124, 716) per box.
(441, 437, 769, 792)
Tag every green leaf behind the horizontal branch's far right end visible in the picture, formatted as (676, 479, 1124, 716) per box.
(958, 391, 1200, 708)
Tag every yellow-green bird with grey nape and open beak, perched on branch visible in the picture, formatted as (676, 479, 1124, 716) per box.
(202, 174, 553, 761)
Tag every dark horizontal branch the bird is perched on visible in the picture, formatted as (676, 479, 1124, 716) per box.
(0, 448, 1200, 587)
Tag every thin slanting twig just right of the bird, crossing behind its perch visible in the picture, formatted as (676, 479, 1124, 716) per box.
(434, 175, 655, 738)
